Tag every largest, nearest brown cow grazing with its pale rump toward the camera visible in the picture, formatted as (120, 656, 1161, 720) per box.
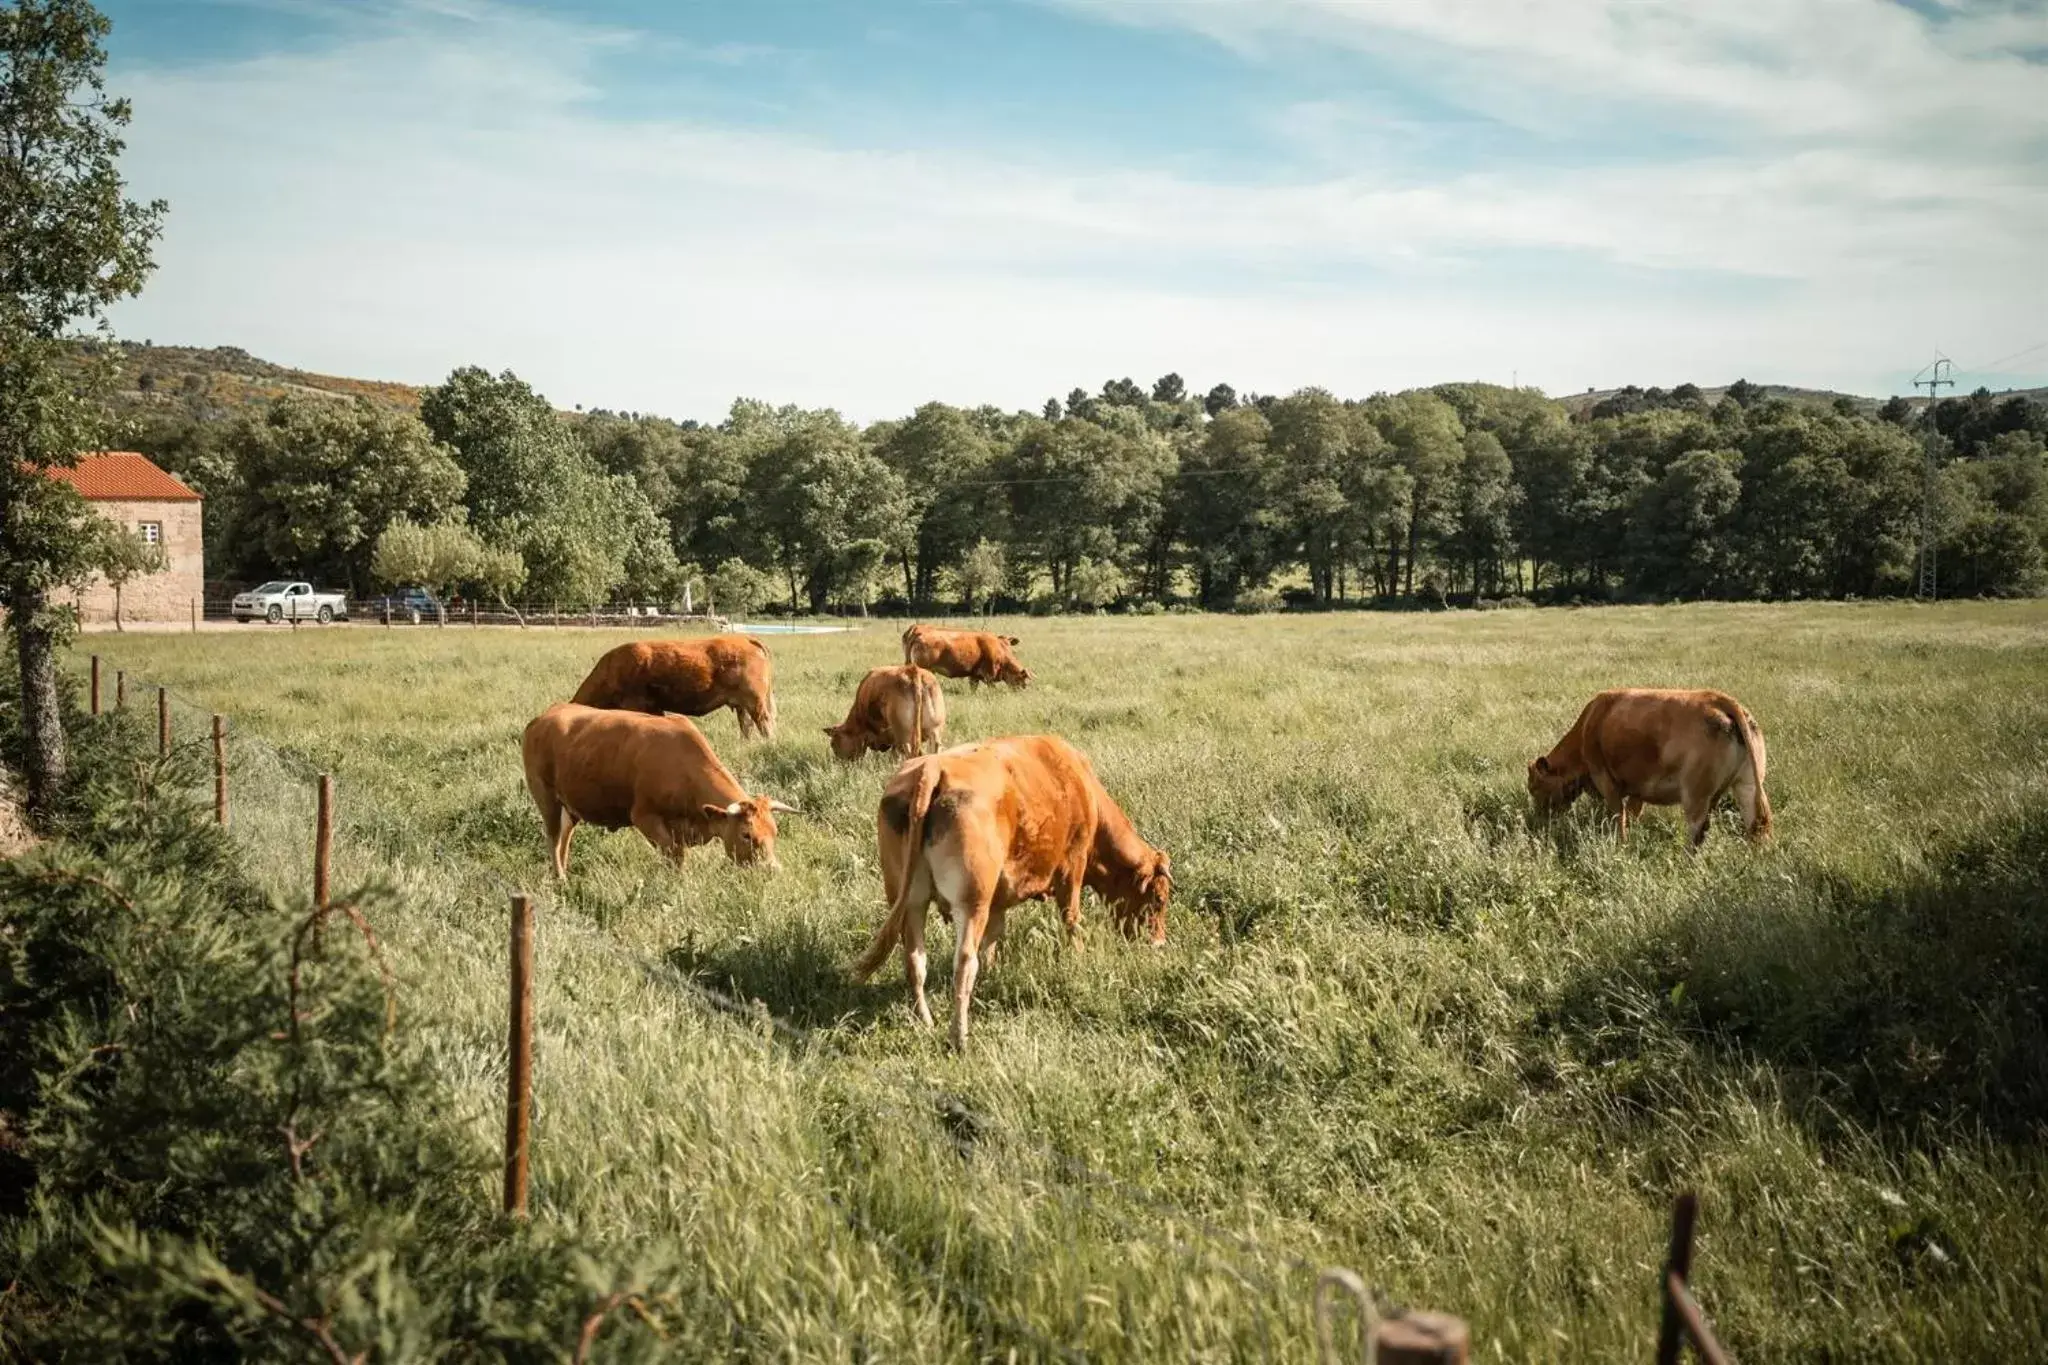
(854, 735, 1174, 1048)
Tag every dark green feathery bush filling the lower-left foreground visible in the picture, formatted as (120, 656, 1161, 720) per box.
(0, 699, 675, 1361)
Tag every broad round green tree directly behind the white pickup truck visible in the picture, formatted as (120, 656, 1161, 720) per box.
(207, 397, 465, 591)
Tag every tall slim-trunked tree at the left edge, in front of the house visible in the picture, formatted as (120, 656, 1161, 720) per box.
(0, 0, 164, 810)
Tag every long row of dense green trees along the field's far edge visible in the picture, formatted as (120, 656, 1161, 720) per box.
(131, 368, 2048, 612)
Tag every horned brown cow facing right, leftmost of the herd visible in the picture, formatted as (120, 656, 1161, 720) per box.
(520, 702, 797, 878)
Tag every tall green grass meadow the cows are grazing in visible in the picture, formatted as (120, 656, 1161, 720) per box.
(74, 602, 2048, 1361)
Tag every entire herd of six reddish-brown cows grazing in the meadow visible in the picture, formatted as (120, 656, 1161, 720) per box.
(522, 624, 1772, 1048)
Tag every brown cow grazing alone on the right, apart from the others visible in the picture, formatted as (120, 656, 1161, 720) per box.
(1530, 688, 1772, 849)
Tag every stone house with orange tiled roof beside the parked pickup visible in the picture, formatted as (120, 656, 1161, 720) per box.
(49, 450, 207, 622)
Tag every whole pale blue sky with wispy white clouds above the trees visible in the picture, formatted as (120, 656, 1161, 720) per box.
(102, 0, 2048, 420)
